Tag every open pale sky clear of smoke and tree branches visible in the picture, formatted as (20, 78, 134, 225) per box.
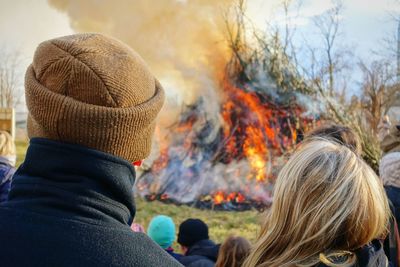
(0, 0, 400, 112)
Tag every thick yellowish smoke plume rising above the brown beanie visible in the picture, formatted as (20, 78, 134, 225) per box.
(49, 0, 233, 125)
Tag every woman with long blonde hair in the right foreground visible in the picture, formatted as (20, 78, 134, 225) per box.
(244, 139, 390, 267)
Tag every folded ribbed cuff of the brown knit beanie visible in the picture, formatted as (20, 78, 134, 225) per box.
(25, 66, 164, 162)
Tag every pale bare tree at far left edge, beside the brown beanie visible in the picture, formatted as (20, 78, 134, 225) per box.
(0, 48, 23, 108)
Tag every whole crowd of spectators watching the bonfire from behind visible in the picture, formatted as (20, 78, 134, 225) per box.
(0, 34, 400, 267)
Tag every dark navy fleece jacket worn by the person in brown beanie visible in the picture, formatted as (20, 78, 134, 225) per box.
(0, 139, 180, 267)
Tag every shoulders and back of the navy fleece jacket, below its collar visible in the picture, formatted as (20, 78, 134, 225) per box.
(0, 207, 181, 267)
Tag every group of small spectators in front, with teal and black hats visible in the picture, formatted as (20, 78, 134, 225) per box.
(131, 215, 251, 267)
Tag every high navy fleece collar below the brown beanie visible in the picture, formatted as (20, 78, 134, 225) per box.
(7, 138, 135, 225)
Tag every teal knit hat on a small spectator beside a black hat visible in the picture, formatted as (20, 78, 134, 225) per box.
(147, 215, 175, 249)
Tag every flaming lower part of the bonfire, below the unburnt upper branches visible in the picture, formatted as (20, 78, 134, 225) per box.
(137, 76, 313, 210)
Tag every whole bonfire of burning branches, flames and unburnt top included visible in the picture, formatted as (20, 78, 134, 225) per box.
(137, 3, 319, 210)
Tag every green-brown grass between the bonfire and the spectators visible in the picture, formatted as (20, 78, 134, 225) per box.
(15, 140, 263, 251)
